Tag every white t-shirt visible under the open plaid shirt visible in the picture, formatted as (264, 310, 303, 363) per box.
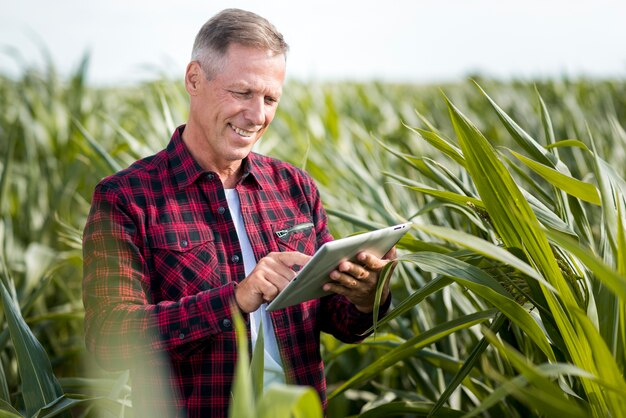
(225, 189, 285, 387)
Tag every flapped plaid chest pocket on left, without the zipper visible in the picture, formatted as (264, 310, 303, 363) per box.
(148, 225, 221, 303)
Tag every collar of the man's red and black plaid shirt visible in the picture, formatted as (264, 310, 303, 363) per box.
(167, 125, 263, 189)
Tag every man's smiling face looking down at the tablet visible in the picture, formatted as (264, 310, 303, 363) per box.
(183, 44, 285, 181)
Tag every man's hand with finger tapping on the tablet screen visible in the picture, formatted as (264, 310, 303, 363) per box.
(235, 251, 311, 313)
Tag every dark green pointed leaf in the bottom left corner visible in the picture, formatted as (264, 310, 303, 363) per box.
(0, 283, 63, 416)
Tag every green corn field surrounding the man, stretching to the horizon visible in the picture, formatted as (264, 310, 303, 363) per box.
(0, 53, 626, 418)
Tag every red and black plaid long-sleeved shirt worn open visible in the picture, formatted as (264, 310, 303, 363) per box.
(83, 126, 388, 417)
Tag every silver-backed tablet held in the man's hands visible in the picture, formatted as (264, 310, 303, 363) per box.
(266, 222, 411, 311)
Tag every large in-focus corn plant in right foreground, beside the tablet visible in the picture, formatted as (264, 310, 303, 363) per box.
(316, 83, 626, 417)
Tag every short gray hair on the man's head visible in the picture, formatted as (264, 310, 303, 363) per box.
(191, 9, 289, 79)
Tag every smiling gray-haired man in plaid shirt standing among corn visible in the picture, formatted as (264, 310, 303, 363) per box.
(83, 9, 393, 417)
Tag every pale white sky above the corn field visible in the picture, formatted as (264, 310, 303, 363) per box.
(0, 0, 626, 84)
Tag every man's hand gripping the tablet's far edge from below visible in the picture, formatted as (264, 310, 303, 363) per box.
(324, 247, 396, 313)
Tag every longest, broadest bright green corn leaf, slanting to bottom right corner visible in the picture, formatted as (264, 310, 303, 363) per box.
(448, 97, 621, 412)
